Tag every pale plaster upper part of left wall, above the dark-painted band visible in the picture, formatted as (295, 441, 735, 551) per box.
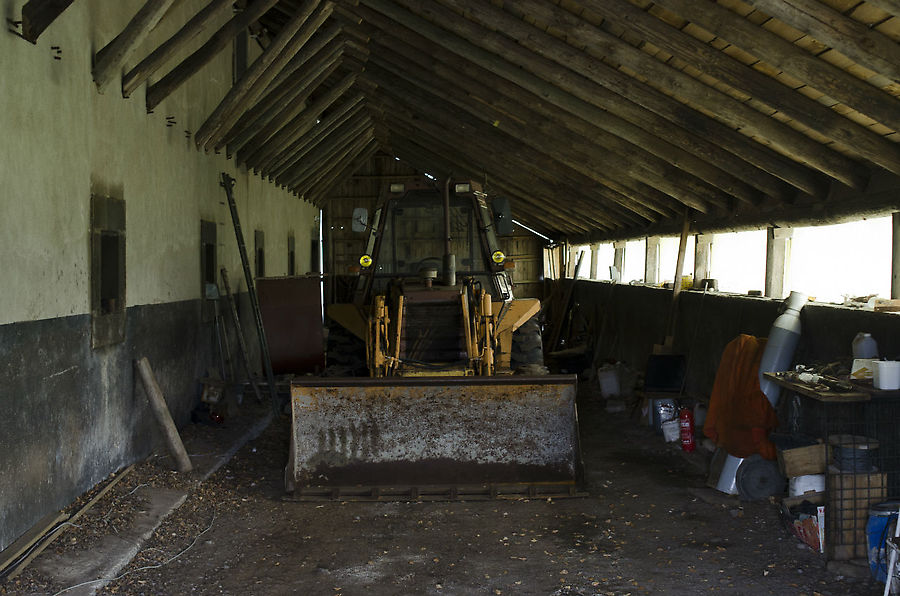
(0, 0, 318, 324)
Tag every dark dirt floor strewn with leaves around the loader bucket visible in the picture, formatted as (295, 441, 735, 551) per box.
(0, 388, 881, 596)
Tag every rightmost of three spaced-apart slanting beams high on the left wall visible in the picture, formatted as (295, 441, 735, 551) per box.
(147, 0, 279, 112)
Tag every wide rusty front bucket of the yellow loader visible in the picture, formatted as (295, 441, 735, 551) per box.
(285, 375, 581, 499)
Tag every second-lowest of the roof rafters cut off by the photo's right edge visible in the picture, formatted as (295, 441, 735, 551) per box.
(656, 0, 900, 130)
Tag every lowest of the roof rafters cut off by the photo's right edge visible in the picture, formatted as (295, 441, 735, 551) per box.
(579, 0, 900, 173)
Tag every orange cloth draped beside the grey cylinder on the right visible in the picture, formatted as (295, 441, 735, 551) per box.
(703, 335, 778, 460)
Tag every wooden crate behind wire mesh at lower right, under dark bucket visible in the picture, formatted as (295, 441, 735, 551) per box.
(825, 466, 887, 560)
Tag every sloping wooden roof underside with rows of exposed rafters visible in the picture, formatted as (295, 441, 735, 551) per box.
(93, 0, 900, 240)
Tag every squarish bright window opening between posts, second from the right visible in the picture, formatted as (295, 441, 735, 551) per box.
(712, 230, 766, 294)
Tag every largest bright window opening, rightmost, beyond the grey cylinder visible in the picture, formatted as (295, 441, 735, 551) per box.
(785, 216, 892, 303)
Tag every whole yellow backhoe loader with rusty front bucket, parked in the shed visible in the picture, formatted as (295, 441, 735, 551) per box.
(285, 179, 581, 499)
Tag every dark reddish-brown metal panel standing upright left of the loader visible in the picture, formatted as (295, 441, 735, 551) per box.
(256, 276, 325, 375)
